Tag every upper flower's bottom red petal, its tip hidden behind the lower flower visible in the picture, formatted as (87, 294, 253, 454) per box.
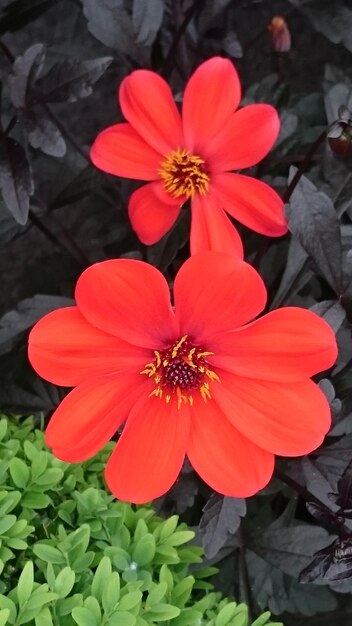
(191, 194, 243, 259)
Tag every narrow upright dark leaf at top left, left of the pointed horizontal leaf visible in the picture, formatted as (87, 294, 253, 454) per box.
(9, 43, 45, 108)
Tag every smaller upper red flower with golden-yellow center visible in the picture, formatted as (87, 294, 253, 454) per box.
(91, 57, 287, 255)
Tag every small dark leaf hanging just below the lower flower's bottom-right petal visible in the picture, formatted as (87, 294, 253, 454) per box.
(199, 493, 246, 559)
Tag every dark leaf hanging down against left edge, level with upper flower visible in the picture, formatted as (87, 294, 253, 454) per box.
(0, 137, 33, 225)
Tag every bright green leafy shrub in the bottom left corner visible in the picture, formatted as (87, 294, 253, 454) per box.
(0, 418, 280, 626)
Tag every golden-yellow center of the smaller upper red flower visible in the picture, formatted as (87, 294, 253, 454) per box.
(159, 150, 209, 198)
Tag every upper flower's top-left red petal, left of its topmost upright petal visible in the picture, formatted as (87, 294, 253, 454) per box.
(119, 70, 183, 155)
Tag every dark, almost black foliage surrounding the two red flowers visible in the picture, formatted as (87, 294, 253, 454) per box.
(0, 0, 352, 626)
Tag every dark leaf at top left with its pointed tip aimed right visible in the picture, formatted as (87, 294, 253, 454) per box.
(36, 57, 112, 102)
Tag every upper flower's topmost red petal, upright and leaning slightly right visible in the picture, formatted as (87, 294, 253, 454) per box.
(182, 57, 241, 153)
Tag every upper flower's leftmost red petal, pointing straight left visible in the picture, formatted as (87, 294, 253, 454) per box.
(90, 124, 162, 180)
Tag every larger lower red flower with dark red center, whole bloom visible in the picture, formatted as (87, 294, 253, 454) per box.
(29, 252, 336, 503)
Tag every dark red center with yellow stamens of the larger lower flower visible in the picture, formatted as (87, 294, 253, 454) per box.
(141, 335, 220, 409)
